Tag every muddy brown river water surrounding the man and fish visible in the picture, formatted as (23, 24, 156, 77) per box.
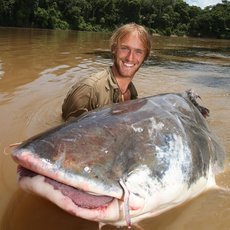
(0, 28, 230, 230)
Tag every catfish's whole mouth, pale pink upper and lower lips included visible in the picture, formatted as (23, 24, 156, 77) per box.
(13, 150, 131, 226)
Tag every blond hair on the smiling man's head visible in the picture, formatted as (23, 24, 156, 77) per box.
(110, 23, 151, 59)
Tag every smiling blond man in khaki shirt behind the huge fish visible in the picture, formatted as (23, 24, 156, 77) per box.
(62, 23, 151, 120)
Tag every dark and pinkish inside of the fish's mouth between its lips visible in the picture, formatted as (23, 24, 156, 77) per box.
(17, 165, 115, 209)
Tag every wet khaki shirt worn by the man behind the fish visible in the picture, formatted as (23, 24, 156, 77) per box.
(62, 67, 138, 120)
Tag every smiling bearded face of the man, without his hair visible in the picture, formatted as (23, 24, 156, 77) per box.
(112, 32, 146, 78)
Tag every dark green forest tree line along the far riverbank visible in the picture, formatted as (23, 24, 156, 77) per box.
(0, 0, 230, 39)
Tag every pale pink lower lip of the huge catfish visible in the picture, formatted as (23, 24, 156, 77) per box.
(19, 172, 128, 225)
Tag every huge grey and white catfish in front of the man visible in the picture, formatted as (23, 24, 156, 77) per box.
(12, 93, 224, 226)
